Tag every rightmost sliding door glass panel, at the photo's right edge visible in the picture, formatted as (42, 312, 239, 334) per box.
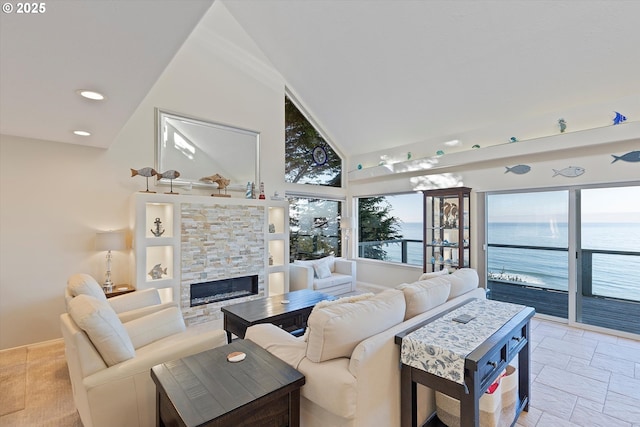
(576, 186, 640, 333)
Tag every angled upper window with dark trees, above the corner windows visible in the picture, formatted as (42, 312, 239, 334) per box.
(284, 97, 342, 187)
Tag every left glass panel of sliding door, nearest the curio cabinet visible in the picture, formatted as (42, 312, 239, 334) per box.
(487, 191, 569, 318)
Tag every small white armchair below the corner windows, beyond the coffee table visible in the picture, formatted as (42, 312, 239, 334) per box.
(289, 256, 356, 295)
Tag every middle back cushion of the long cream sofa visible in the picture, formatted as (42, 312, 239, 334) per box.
(397, 277, 451, 320)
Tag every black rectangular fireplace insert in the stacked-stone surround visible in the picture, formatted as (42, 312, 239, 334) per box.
(190, 275, 258, 307)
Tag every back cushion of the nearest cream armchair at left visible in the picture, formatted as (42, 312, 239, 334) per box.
(69, 295, 136, 366)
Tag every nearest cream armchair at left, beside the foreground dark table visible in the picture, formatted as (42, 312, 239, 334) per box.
(60, 295, 227, 427)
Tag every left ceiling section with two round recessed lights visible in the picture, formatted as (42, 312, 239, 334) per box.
(0, 0, 213, 147)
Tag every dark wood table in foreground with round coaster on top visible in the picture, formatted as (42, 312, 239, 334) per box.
(151, 340, 305, 427)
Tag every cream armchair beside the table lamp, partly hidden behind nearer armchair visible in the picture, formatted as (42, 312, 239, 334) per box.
(64, 273, 178, 322)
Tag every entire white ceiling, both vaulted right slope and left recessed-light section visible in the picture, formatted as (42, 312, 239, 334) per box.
(0, 0, 640, 154)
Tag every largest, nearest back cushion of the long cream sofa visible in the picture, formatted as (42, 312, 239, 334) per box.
(307, 289, 405, 363)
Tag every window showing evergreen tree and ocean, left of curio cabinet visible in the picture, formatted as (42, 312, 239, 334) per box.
(358, 193, 424, 266)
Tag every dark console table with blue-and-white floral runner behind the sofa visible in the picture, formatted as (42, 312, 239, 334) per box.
(395, 299, 535, 427)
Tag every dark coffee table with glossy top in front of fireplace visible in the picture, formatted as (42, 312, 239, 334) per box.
(221, 289, 336, 342)
